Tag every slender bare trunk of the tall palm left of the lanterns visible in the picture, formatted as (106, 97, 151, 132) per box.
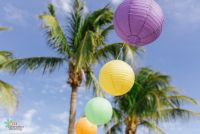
(68, 86, 78, 134)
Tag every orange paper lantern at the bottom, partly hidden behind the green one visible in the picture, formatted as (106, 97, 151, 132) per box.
(76, 118, 97, 134)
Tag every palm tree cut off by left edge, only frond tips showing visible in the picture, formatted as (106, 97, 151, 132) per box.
(0, 27, 18, 114)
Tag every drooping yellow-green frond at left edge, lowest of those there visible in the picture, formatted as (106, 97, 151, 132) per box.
(0, 80, 18, 114)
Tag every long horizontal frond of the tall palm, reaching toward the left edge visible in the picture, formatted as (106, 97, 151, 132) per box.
(3, 57, 64, 73)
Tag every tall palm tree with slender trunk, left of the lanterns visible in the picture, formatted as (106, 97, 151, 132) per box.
(1, 0, 137, 134)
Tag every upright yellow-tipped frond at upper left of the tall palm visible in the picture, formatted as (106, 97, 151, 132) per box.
(39, 4, 70, 57)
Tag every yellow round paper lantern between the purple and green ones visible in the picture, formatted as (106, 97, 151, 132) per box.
(99, 60, 135, 96)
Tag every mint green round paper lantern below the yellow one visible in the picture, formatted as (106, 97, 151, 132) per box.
(85, 97, 113, 125)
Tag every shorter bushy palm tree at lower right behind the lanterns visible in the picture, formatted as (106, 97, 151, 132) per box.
(106, 68, 200, 134)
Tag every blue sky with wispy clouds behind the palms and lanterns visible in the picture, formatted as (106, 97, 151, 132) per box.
(0, 0, 200, 134)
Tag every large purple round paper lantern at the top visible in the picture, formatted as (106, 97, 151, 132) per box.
(114, 0, 164, 46)
